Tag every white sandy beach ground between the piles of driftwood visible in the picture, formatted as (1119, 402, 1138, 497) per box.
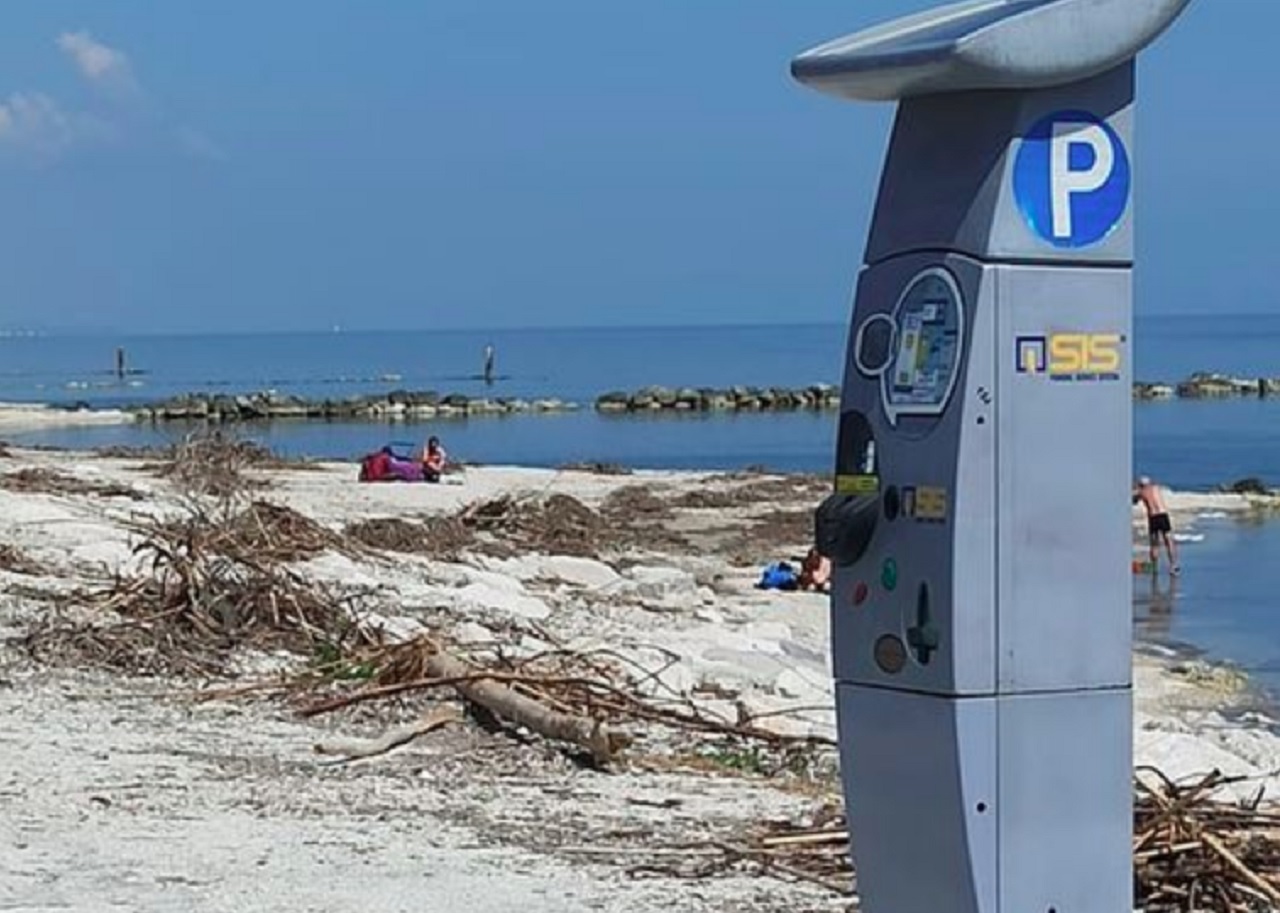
(0, 449, 1280, 913)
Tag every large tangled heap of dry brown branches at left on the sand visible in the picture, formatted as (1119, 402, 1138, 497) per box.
(26, 502, 379, 675)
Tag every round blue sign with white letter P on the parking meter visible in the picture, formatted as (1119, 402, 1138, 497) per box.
(1014, 111, 1130, 247)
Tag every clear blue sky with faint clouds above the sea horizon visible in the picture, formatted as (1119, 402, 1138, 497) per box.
(0, 0, 1259, 332)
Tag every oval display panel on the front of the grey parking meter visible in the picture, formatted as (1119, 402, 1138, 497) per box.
(887, 271, 960, 414)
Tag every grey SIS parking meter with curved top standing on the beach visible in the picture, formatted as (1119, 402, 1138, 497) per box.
(792, 0, 1187, 913)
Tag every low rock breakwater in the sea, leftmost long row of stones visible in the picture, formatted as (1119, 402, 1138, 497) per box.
(129, 391, 579, 423)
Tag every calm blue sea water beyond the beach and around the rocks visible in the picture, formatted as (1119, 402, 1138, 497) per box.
(0, 314, 1280, 695)
